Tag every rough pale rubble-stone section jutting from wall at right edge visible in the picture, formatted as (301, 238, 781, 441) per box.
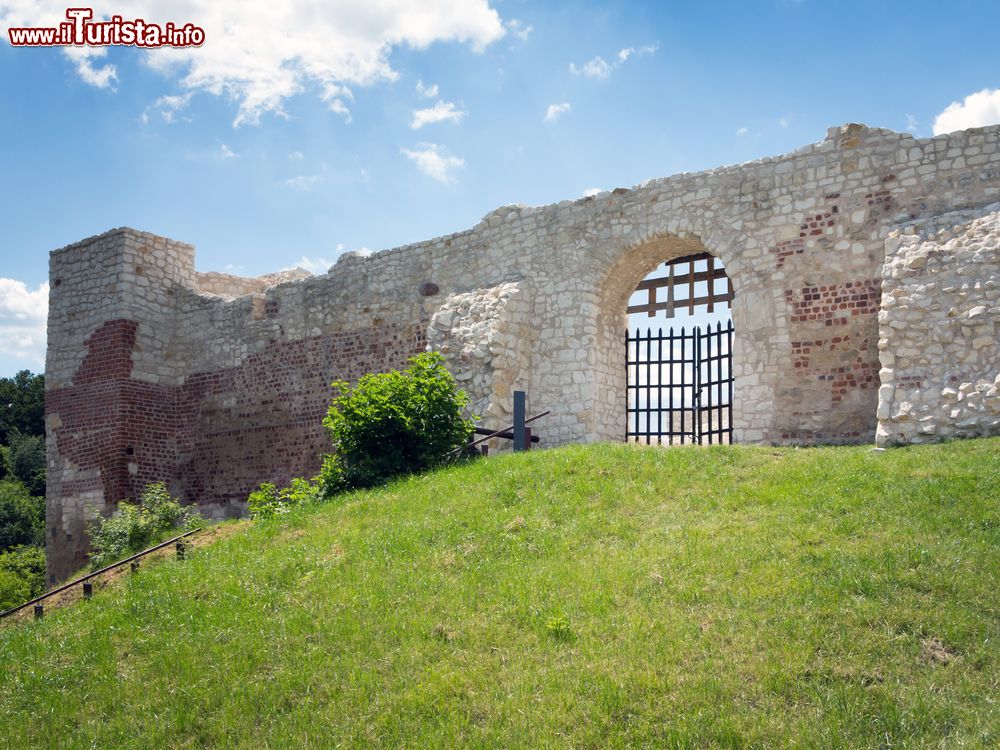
(876, 203, 1000, 445)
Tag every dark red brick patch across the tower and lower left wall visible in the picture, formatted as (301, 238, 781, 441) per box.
(46, 319, 426, 572)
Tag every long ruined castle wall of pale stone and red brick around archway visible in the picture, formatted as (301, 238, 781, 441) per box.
(46, 125, 1000, 576)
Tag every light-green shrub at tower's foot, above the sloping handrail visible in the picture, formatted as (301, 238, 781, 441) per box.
(87, 482, 204, 570)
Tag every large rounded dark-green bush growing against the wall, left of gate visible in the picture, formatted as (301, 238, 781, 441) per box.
(321, 352, 473, 496)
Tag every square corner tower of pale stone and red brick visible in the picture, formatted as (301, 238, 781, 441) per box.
(45, 231, 194, 574)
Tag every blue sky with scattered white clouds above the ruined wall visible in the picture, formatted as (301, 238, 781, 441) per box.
(0, 0, 1000, 375)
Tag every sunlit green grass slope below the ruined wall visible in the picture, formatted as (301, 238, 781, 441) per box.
(0, 439, 1000, 748)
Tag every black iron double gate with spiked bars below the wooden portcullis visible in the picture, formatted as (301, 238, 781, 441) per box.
(625, 320, 733, 445)
